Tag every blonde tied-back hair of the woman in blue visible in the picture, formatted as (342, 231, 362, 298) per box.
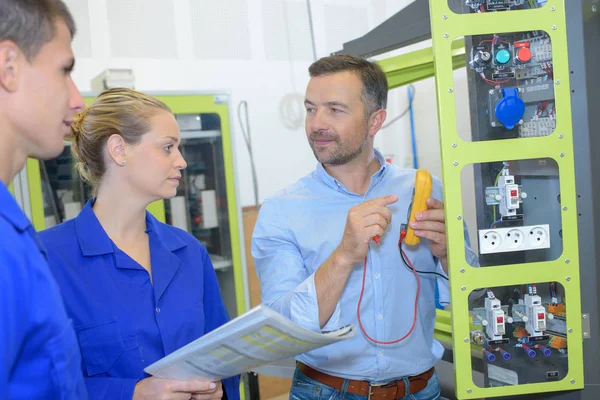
(69, 88, 172, 195)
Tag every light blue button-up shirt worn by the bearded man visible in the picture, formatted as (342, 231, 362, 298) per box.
(252, 151, 477, 382)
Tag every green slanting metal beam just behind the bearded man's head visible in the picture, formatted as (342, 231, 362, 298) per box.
(378, 40, 465, 89)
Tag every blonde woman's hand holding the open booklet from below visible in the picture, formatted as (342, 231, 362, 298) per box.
(133, 377, 223, 400)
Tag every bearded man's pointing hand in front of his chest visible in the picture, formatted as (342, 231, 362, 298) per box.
(334, 195, 398, 265)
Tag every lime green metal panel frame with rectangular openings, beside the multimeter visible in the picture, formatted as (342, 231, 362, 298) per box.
(430, 0, 584, 399)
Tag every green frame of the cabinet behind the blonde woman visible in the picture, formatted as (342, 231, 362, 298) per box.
(27, 93, 247, 315)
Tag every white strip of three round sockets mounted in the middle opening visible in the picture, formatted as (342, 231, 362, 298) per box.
(479, 224, 550, 254)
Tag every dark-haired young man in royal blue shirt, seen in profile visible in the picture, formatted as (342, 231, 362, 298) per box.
(0, 0, 87, 399)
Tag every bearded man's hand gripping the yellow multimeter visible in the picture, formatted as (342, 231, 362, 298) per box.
(410, 197, 448, 273)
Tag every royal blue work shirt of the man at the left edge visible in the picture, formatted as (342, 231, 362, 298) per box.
(0, 181, 87, 399)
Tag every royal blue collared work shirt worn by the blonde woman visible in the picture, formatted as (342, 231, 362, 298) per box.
(40, 200, 239, 400)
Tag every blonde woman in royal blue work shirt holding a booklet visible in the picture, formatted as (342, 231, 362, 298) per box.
(40, 89, 239, 400)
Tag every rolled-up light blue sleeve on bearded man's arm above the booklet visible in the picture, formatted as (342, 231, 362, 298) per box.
(252, 200, 341, 332)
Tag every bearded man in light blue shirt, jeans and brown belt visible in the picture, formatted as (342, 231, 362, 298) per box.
(252, 56, 477, 400)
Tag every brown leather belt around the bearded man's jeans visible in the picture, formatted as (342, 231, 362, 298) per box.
(296, 361, 434, 400)
